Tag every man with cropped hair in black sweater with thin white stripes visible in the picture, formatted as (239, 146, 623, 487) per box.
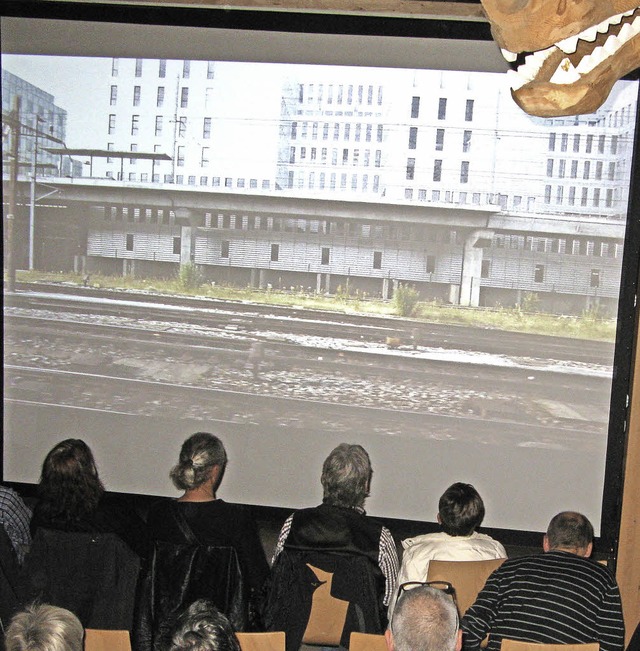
(462, 511, 624, 651)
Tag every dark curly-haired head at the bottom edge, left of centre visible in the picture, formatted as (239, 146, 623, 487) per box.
(166, 599, 240, 651)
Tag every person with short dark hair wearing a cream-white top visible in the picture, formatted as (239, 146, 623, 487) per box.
(398, 482, 507, 584)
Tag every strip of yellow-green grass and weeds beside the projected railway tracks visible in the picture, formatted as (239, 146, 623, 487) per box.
(12, 271, 616, 342)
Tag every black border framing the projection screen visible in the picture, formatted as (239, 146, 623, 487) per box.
(0, 0, 640, 564)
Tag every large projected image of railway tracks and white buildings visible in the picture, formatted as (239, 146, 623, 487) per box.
(2, 45, 638, 531)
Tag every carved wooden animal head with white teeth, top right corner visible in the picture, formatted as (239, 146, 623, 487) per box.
(481, 0, 640, 117)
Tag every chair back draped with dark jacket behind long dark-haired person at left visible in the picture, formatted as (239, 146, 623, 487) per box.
(24, 529, 140, 630)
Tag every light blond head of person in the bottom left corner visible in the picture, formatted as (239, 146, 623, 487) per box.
(4, 604, 84, 651)
